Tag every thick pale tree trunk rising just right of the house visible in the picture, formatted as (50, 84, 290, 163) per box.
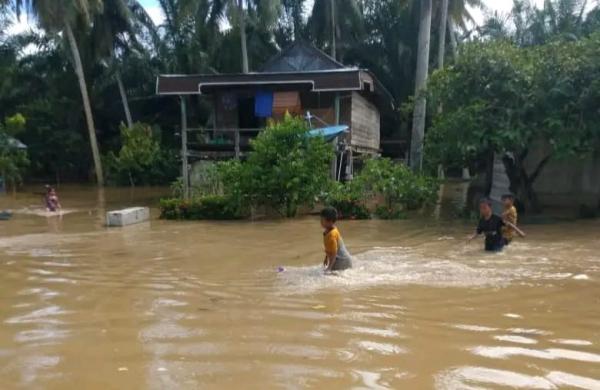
(410, 0, 431, 171)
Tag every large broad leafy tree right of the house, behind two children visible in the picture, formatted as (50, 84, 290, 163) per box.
(426, 34, 600, 208)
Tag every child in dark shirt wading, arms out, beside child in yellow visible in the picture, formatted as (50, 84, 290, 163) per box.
(469, 198, 525, 252)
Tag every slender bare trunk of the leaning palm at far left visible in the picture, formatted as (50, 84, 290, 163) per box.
(65, 21, 104, 187)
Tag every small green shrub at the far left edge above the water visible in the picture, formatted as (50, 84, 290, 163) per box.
(0, 114, 29, 191)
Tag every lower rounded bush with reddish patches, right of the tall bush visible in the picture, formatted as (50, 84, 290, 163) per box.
(326, 158, 439, 219)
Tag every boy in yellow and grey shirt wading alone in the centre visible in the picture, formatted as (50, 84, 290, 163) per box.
(321, 207, 352, 272)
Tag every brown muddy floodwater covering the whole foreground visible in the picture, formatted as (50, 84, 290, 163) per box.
(0, 188, 600, 389)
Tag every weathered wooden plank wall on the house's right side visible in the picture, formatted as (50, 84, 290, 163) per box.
(350, 92, 381, 152)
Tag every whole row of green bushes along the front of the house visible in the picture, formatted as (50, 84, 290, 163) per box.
(161, 116, 438, 219)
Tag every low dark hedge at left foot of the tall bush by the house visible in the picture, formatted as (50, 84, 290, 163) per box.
(160, 195, 244, 220)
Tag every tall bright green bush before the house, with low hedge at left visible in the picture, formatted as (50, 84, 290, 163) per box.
(161, 116, 333, 219)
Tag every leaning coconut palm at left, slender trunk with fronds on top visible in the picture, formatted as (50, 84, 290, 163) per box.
(11, 0, 104, 187)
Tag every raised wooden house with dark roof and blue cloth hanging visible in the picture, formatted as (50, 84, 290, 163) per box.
(156, 41, 393, 195)
